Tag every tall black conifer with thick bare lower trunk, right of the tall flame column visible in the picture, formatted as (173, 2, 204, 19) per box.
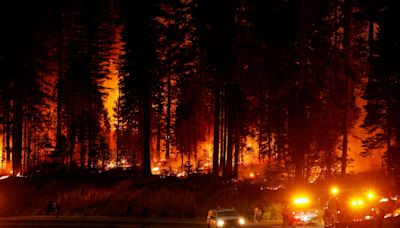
(121, 1, 158, 176)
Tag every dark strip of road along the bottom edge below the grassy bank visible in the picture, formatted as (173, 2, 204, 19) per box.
(0, 216, 323, 228)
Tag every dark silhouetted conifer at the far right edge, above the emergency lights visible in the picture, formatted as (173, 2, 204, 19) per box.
(363, 1, 400, 183)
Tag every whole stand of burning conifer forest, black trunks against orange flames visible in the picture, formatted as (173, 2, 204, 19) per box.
(0, 0, 400, 183)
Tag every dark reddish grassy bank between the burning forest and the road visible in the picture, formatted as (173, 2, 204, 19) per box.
(0, 175, 277, 219)
